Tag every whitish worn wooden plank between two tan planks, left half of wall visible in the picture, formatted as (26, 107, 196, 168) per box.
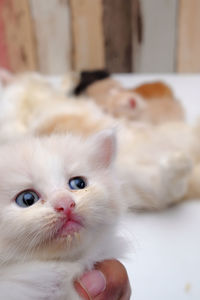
(29, 0, 71, 74)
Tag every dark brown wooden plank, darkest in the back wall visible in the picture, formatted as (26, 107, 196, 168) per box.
(103, 0, 132, 73)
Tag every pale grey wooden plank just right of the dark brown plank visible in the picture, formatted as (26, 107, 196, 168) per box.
(133, 0, 177, 73)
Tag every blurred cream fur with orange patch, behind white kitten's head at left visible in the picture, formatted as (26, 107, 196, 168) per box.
(0, 73, 113, 141)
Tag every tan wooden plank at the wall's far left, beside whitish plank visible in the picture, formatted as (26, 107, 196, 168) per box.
(0, 0, 37, 71)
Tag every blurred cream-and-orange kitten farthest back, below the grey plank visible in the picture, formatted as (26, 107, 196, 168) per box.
(86, 79, 184, 124)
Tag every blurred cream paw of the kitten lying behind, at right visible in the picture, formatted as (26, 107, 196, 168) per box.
(160, 152, 192, 202)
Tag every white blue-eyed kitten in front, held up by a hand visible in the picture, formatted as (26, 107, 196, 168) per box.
(0, 131, 124, 300)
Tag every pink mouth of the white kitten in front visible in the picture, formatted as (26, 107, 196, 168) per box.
(56, 215, 83, 238)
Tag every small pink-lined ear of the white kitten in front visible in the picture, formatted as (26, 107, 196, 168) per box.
(91, 130, 116, 168)
